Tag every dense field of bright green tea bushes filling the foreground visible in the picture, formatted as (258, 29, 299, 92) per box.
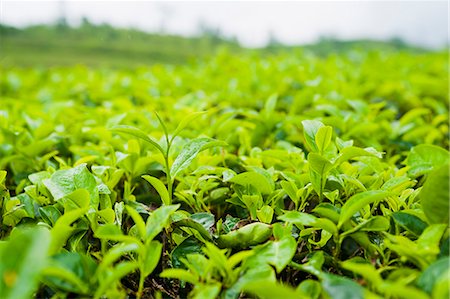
(0, 51, 450, 299)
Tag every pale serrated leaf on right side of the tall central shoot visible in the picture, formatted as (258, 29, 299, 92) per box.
(170, 138, 226, 179)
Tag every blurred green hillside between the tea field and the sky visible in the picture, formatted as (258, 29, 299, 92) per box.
(0, 21, 425, 68)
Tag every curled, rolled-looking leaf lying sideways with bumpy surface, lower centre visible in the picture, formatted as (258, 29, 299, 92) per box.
(217, 222, 272, 248)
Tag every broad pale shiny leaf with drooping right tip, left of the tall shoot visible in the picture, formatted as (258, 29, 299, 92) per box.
(43, 164, 98, 205)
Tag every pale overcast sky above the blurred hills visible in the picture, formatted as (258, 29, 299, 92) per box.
(0, 0, 449, 48)
